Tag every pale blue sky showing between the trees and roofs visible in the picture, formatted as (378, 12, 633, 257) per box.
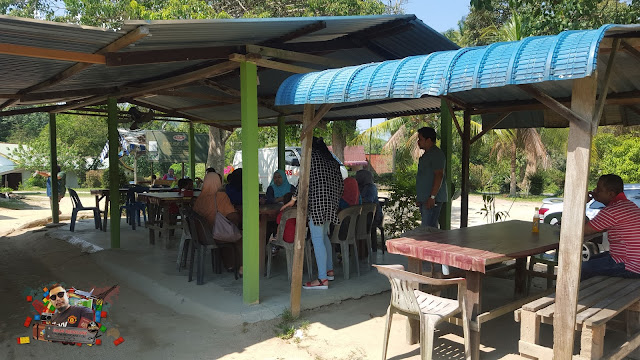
(358, 0, 469, 131)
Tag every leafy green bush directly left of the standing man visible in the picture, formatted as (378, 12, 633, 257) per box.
(382, 164, 420, 238)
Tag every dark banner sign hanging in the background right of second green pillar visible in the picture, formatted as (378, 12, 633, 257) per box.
(146, 130, 209, 163)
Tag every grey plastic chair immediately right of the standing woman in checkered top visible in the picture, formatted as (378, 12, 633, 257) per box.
(330, 205, 362, 280)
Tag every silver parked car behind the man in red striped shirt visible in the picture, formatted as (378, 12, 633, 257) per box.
(539, 184, 640, 261)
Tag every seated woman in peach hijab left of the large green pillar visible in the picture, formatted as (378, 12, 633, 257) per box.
(193, 172, 242, 273)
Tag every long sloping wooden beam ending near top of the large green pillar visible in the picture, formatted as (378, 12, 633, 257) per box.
(55, 61, 239, 112)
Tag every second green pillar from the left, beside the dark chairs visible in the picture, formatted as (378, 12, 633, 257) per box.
(105, 98, 120, 249)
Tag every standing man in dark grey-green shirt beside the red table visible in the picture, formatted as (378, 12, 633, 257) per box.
(416, 127, 447, 228)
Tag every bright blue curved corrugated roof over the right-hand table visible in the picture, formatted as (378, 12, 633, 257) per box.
(276, 25, 640, 127)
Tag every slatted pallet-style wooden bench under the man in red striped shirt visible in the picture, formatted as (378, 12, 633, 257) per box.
(515, 276, 640, 359)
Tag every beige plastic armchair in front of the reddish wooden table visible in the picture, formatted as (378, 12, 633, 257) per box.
(373, 265, 471, 360)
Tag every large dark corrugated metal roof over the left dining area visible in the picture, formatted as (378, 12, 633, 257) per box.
(0, 15, 457, 126)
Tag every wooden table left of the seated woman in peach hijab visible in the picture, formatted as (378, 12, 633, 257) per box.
(138, 191, 200, 249)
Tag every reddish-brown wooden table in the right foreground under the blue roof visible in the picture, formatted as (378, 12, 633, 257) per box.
(386, 220, 560, 359)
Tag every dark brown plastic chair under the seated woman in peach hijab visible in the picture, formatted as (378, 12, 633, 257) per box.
(184, 209, 238, 285)
